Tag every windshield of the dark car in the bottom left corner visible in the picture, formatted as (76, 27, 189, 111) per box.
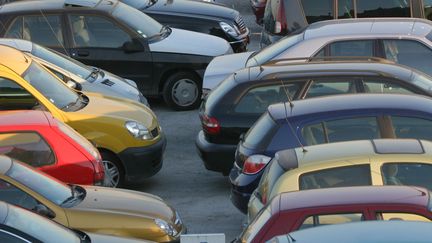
(3, 206, 81, 243)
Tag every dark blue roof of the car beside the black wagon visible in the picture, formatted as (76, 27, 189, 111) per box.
(267, 94, 432, 121)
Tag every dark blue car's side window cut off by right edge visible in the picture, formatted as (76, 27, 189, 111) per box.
(391, 116, 432, 140)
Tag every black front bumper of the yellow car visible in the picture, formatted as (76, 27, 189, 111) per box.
(119, 133, 166, 184)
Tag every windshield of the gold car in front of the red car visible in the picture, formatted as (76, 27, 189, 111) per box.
(6, 162, 73, 205)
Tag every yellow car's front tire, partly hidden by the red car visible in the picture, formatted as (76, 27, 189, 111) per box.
(100, 151, 125, 187)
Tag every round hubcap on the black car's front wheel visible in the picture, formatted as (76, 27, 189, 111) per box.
(171, 78, 198, 106)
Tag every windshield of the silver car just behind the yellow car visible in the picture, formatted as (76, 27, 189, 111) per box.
(31, 44, 93, 80)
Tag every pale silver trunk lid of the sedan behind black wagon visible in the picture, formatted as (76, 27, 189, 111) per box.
(203, 52, 253, 90)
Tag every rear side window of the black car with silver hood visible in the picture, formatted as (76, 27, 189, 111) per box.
(5, 15, 64, 47)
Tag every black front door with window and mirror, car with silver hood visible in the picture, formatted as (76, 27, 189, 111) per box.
(66, 11, 153, 93)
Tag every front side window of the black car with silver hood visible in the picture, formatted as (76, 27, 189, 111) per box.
(69, 14, 132, 49)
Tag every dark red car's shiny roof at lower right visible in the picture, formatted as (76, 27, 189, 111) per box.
(276, 186, 429, 213)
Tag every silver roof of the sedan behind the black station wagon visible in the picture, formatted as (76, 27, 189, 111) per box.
(303, 18, 432, 40)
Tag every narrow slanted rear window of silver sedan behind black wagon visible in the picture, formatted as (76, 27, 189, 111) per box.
(246, 33, 303, 67)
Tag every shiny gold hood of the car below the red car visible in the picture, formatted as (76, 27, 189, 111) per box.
(71, 187, 176, 222)
